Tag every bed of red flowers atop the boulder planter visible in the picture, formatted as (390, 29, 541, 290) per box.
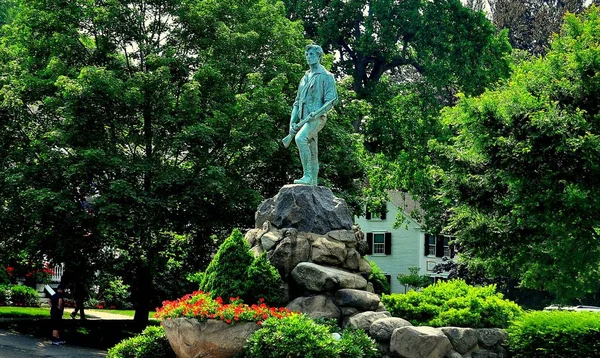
(155, 291, 295, 324)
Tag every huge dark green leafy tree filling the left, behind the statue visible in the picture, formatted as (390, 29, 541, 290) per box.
(0, 0, 361, 325)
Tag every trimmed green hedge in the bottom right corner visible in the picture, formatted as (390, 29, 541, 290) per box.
(507, 311, 600, 358)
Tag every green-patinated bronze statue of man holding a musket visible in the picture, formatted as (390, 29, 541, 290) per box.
(284, 45, 338, 185)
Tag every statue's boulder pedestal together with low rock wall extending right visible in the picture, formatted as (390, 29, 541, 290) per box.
(246, 185, 507, 358)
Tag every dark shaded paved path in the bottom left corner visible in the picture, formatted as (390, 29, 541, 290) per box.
(0, 330, 106, 358)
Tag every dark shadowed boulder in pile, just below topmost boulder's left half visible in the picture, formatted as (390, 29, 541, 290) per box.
(269, 237, 310, 279)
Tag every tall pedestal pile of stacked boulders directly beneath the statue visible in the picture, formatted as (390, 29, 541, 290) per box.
(246, 185, 382, 323)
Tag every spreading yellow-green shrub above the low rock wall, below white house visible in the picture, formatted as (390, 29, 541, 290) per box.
(381, 280, 523, 328)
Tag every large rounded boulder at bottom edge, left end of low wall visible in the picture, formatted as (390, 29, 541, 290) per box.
(390, 326, 452, 358)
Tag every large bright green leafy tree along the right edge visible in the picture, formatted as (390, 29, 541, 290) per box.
(422, 6, 600, 303)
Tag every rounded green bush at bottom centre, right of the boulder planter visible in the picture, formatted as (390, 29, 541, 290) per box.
(244, 314, 380, 358)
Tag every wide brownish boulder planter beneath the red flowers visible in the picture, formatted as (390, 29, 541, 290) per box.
(162, 318, 260, 358)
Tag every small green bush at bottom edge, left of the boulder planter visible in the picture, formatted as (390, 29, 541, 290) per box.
(108, 326, 177, 358)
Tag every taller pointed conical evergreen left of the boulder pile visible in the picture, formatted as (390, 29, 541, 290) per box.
(200, 229, 254, 300)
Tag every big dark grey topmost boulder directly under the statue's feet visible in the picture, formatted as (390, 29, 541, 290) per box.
(255, 184, 352, 235)
